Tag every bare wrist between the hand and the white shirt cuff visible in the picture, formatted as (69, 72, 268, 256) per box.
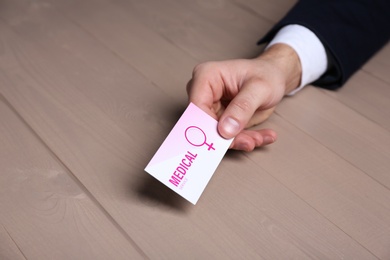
(259, 43, 302, 95)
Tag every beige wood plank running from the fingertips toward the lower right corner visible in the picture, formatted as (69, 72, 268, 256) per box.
(247, 108, 390, 259)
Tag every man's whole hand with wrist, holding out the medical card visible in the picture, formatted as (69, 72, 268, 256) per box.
(187, 44, 301, 151)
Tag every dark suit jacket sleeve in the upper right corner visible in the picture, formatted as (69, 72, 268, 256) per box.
(259, 0, 390, 89)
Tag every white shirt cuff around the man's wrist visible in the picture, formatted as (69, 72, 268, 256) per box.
(267, 24, 328, 95)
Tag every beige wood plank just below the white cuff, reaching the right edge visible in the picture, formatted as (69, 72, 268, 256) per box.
(277, 86, 390, 189)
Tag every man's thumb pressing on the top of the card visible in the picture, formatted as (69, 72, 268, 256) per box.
(218, 81, 268, 139)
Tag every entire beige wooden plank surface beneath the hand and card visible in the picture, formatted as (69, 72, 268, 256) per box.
(0, 0, 390, 259)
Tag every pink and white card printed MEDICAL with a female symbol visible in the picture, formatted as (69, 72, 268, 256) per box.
(145, 103, 233, 205)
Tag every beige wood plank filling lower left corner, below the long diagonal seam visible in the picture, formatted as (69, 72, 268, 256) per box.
(0, 96, 142, 259)
